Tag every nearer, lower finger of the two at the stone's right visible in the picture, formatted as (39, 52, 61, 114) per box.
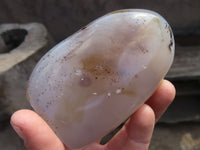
(106, 104, 155, 150)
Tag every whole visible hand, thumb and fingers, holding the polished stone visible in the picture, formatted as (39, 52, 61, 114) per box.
(11, 80, 175, 150)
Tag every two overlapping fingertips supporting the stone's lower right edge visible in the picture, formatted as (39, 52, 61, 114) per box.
(106, 80, 175, 150)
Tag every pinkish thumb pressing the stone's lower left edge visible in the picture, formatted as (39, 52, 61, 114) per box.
(11, 110, 65, 150)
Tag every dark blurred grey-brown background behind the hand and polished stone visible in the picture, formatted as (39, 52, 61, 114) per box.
(0, 0, 200, 150)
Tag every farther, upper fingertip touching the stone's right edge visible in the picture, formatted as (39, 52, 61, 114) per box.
(146, 80, 176, 121)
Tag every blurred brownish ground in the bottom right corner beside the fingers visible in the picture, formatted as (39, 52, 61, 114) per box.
(150, 122, 200, 150)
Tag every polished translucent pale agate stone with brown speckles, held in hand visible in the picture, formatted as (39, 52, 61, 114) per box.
(27, 9, 174, 148)
